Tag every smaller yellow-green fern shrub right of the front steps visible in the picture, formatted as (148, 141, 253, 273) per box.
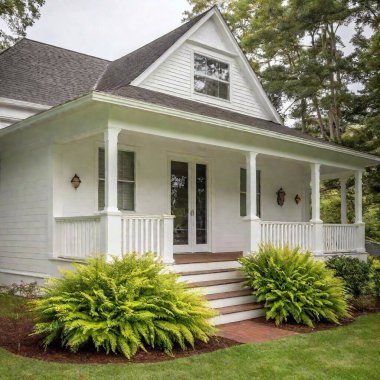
(240, 245, 349, 326)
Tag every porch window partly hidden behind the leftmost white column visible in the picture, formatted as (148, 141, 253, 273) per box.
(98, 148, 135, 211)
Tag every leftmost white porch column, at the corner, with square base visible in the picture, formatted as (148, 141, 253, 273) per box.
(100, 126, 122, 259)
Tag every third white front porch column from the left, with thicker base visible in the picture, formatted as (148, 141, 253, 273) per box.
(310, 163, 324, 255)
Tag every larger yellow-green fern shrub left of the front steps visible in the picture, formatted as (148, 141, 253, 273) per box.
(32, 254, 215, 358)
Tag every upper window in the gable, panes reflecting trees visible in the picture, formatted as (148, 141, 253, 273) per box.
(194, 54, 230, 100)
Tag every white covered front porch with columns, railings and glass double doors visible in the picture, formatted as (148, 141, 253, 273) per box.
(53, 121, 365, 264)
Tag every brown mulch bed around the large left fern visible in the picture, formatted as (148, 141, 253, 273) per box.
(0, 318, 239, 364)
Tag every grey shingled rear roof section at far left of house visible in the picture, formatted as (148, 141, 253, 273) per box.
(0, 38, 108, 106)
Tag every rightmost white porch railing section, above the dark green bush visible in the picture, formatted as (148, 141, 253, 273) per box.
(323, 224, 358, 253)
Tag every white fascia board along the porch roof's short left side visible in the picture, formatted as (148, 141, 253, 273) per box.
(0, 94, 92, 138)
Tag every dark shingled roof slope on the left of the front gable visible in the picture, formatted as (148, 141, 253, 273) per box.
(96, 10, 210, 91)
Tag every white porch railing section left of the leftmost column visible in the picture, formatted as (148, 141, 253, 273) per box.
(54, 216, 100, 259)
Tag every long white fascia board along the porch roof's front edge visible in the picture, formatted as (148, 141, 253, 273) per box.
(92, 92, 380, 165)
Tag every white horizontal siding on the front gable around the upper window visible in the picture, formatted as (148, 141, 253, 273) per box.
(141, 43, 270, 120)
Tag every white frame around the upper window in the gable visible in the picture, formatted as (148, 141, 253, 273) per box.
(191, 50, 232, 105)
